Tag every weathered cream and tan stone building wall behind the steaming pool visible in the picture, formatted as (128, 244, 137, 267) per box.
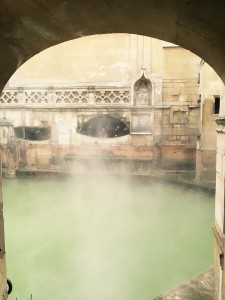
(0, 34, 222, 180)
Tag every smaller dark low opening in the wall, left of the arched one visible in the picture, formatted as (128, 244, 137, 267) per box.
(14, 126, 51, 141)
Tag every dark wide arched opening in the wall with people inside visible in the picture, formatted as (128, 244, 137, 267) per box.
(79, 115, 130, 138)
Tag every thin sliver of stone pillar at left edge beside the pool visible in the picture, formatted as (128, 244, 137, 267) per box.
(0, 154, 7, 300)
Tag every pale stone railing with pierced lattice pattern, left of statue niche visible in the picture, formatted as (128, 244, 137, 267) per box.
(0, 87, 131, 107)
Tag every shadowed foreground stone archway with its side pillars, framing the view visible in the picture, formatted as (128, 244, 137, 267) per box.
(0, 0, 225, 299)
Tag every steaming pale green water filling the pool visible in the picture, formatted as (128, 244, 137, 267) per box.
(3, 176, 214, 300)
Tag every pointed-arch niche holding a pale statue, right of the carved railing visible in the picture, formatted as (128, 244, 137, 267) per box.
(134, 74, 152, 106)
